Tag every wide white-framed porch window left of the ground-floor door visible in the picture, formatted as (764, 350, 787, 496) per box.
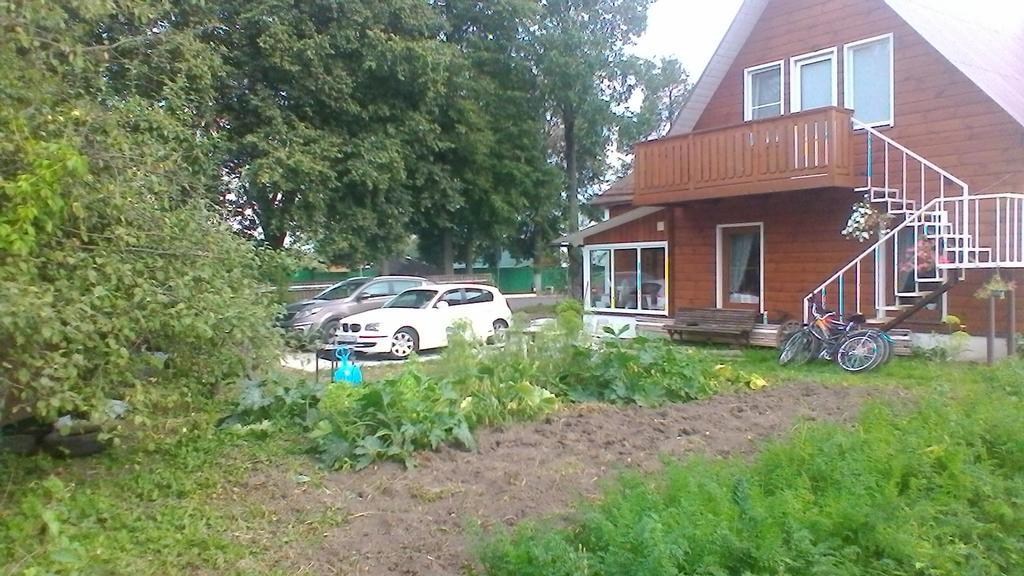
(584, 242, 669, 316)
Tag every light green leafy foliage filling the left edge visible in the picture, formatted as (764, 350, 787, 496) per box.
(0, 1, 278, 417)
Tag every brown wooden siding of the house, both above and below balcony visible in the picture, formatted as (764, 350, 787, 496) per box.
(671, 0, 1024, 334)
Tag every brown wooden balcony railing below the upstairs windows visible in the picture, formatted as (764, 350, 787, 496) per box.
(633, 108, 862, 205)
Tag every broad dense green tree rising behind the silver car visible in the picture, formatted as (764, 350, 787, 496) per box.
(205, 0, 453, 261)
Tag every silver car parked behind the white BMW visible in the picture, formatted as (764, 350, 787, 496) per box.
(279, 276, 430, 341)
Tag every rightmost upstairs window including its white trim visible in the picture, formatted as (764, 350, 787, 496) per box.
(843, 34, 894, 126)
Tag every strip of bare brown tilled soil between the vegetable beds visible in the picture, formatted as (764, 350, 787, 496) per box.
(245, 383, 882, 575)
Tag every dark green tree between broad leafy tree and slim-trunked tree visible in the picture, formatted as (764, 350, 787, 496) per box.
(420, 0, 558, 270)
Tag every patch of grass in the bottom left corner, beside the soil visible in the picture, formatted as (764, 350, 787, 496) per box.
(0, 393, 327, 575)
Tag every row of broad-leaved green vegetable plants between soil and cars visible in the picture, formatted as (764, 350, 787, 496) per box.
(310, 313, 751, 467)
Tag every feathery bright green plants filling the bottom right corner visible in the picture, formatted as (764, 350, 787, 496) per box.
(480, 368, 1024, 576)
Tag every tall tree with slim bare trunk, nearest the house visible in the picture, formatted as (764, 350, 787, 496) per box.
(536, 0, 651, 297)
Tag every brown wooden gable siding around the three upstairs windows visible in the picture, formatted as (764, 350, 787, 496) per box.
(695, 0, 1024, 194)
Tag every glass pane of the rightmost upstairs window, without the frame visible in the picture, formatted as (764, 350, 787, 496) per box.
(850, 39, 893, 124)
